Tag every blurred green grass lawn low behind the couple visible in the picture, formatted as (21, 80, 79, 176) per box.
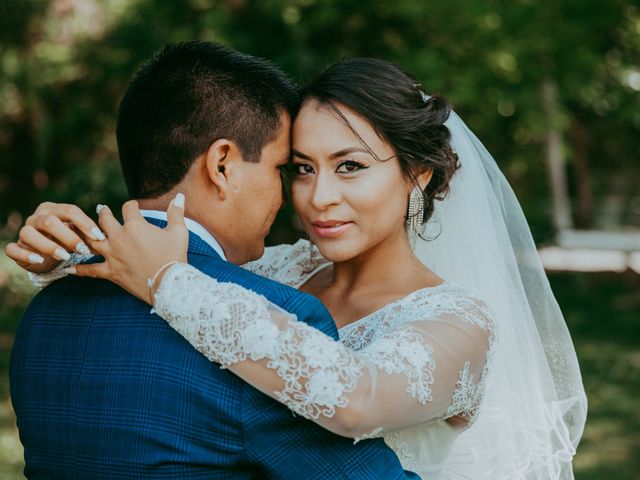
(0, 273, 640, 480)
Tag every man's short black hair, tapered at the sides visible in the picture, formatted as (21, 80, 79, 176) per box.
(117, 41, 299, 198)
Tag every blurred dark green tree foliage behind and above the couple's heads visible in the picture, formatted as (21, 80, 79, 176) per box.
(0, 0, 640, 240)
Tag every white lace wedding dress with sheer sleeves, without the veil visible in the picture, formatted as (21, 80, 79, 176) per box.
(30, 240, 496, 480)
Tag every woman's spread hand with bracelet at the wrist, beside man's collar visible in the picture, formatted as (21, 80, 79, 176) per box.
(67, 193, 189, 304)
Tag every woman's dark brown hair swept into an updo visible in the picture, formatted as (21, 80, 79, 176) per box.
(302, 58, 460, 223)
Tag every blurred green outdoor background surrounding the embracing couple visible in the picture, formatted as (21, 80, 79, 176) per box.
(0, 0, 640, 480)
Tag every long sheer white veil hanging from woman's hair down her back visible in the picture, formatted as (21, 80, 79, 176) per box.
(414, 112, 587, 480)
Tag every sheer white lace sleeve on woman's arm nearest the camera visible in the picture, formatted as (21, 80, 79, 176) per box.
(154, 264, 493, 438)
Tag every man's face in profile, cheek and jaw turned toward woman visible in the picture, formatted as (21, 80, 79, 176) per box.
(219, 115, 291, 264)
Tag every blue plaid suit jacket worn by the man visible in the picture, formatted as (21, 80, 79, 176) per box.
(10, 221, 418, 480)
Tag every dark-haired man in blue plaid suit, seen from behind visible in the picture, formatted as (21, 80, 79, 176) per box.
(7, 42, 417, 480)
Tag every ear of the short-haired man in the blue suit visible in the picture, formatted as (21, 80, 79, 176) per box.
(204, 138, 244, 200)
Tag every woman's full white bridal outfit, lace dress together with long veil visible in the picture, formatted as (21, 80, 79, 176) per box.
(32, 107, 587, 480)
